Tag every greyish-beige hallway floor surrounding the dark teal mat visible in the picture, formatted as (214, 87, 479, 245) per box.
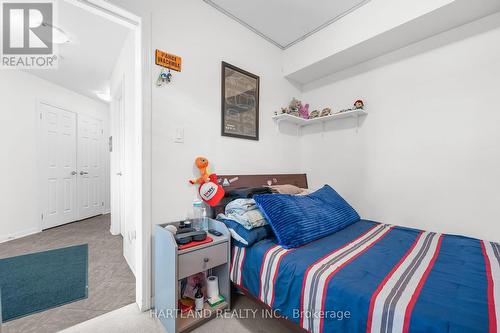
(0, 215, 135, 333)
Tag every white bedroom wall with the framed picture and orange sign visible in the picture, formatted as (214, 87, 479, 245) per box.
(152, 0, 301, 223)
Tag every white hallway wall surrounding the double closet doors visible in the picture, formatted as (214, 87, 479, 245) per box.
(0, 70, 109, 241)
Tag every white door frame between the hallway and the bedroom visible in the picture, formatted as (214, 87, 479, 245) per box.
(65, 0, 153, 311)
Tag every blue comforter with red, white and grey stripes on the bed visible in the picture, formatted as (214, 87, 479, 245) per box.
(231, 220, 500, 333)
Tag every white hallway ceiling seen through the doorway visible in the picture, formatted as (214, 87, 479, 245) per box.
(28, 1, 130, 101)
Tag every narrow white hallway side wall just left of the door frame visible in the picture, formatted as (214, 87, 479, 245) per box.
(110, 31, 139, 273)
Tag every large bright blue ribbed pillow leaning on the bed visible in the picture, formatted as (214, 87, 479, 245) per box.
(254, 185, 360, 248)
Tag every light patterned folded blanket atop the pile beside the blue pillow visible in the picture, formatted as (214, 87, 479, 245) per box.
(223, 199, 267, 230)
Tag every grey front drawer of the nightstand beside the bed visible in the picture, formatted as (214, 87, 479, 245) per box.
(178, 242, 228, 280)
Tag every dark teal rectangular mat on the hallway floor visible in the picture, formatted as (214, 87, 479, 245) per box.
(0, 244, 88, 322)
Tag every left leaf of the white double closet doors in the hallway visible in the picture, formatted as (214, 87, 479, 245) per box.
(39, 103, 78, 229)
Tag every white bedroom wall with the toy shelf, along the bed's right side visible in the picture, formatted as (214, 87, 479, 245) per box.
(301, 25, 500, 241)
